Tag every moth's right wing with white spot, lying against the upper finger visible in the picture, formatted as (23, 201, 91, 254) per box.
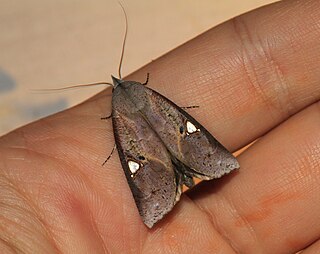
(124, 84, 239, 180)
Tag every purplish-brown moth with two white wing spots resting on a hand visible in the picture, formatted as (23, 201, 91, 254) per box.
(112, 77, 239, 228)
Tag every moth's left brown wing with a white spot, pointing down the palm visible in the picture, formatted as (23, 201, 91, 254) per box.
(112, 87, 181, 228)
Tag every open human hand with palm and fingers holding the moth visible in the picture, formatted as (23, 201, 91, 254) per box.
(0, 0, 320, 254)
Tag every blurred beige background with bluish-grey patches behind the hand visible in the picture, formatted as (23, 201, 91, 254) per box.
(0, 0, 276, 135)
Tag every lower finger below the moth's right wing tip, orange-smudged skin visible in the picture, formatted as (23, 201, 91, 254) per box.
(189, 103, 320, 253)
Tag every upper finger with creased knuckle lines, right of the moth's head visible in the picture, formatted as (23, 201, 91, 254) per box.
(128, 0, 320, 150)
